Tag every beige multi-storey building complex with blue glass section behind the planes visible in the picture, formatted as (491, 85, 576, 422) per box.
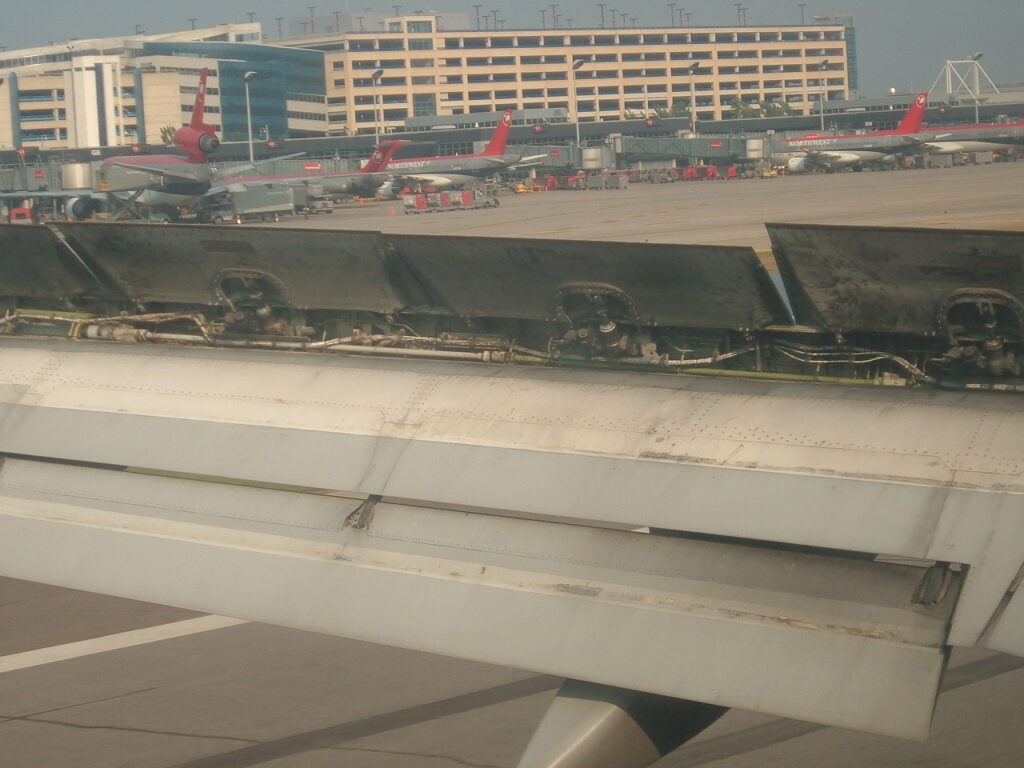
(0, 12, 857, 150)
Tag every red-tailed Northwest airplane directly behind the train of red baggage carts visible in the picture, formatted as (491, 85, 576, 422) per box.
(380, 110, 547, 195)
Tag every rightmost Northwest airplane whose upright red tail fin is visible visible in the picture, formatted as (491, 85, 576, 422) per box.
(774, 93, 928, 173)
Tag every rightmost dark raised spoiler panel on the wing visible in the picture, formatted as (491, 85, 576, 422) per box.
(765, 223, 1024, 333)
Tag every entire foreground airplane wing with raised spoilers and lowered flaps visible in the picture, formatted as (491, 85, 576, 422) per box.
(0, 223, 1024, 768)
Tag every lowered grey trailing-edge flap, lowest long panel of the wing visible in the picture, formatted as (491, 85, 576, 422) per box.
(0, 460, 951, 738)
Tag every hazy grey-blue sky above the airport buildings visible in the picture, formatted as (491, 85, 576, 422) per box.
(0, 0, 1024, 96)
